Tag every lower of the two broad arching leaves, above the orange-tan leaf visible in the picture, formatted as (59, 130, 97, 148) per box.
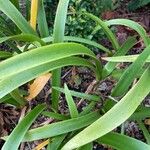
(0, 57, 95, 98)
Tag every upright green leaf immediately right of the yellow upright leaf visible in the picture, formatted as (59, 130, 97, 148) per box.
(38, 0, 49, 37)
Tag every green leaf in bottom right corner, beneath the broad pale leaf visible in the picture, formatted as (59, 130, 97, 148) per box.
(97, 132, 150, 150)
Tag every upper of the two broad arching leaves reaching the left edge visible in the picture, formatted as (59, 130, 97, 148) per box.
(0, 43, 99, 79)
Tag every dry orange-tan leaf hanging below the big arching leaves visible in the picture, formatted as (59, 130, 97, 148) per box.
(26, 73, 52, 101)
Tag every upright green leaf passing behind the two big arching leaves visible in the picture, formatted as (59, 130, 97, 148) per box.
(52, 0, 69, 110)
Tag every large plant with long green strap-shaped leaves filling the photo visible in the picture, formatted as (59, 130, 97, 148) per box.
(0, 0, 150, 150)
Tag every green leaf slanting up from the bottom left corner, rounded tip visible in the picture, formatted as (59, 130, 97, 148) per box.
(2, 104, 45, 150)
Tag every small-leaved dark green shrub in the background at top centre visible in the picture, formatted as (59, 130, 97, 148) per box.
(45, 0, 117, 39)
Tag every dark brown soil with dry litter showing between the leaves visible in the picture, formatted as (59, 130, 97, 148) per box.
(0, 0, 150, 150)
